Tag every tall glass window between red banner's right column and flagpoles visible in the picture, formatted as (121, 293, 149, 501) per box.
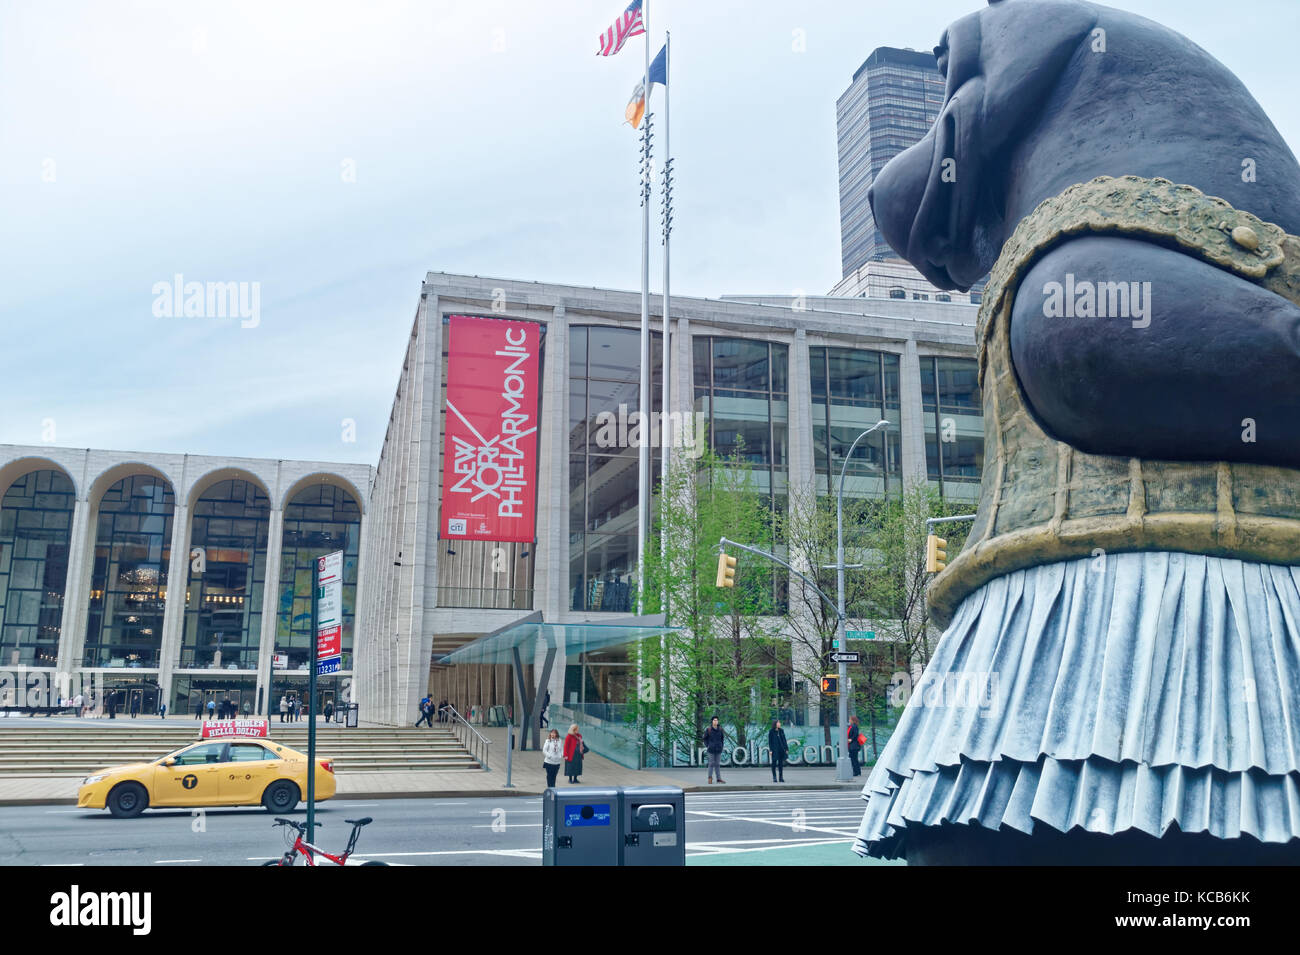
(568, 325, 663, 613)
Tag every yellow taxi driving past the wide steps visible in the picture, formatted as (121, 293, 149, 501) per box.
(77, 737, 335, 819)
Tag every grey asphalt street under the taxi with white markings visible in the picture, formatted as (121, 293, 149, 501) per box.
(0, 790, 863, 865)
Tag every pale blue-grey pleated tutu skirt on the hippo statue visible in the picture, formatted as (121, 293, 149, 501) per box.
(854, 552, 1300, 858)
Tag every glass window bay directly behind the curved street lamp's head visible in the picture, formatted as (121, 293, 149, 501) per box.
(809, 347, 902, 498)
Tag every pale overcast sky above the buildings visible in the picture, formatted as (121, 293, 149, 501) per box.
(0, 0, 1300, 464)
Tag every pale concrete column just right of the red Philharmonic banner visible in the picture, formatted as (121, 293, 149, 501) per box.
(530, 305, 569, 621)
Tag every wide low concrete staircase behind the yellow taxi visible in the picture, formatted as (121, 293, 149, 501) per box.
(0, 717, 482, 777)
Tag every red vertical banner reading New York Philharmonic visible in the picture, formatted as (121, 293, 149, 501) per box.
(439, 314, 541, 543)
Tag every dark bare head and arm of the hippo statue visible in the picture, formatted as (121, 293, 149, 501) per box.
(868, 0, 1300, 468)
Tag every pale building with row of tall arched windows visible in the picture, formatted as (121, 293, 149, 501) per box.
(0, 446, 373, 713)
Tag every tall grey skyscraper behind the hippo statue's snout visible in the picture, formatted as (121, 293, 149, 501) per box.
(831, 47, 983, 303)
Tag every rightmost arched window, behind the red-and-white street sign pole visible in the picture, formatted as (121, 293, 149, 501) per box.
(276, 485, 361, 670)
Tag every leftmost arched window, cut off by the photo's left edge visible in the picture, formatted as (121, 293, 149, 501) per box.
(0, 470, 77, 667)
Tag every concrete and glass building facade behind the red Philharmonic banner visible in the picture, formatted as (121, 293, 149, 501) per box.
(356, 273, 983, 724)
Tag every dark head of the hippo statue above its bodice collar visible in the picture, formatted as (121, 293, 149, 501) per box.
(868, 0, 1300, 288)
